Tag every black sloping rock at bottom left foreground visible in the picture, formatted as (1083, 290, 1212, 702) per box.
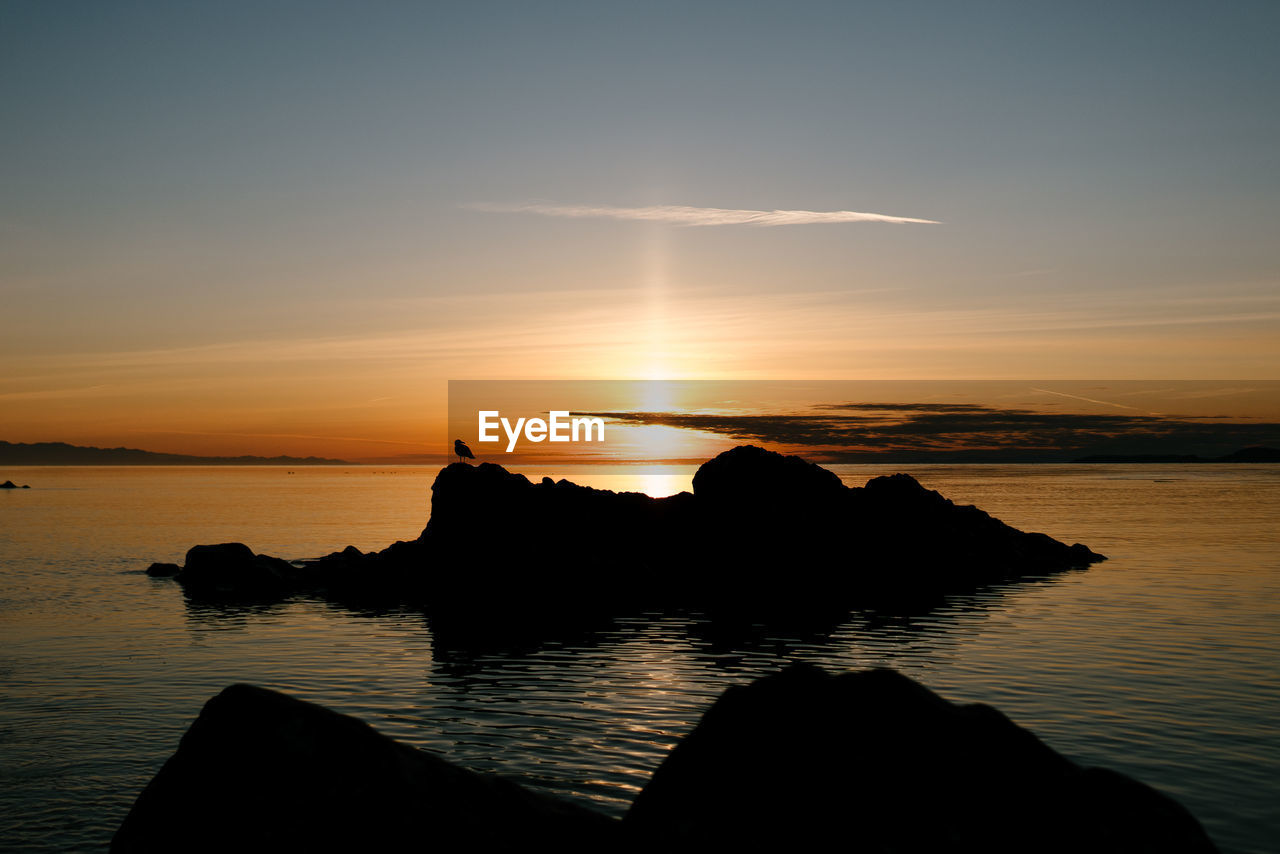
(111, 685, 621, 854)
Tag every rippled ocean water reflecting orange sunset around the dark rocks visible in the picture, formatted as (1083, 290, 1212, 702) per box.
(0, 465, 1280, 854)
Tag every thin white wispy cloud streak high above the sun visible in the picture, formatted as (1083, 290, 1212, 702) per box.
(467, 202, 940, 225)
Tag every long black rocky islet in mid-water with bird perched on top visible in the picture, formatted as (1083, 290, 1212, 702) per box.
(157, 446, 1103, 618)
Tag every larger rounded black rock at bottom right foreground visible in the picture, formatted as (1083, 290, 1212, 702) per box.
(623, 666, 1215, 854)
